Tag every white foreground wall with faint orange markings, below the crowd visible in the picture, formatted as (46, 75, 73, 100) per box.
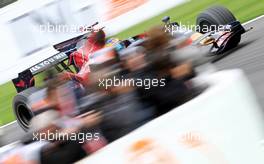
(78, 70, 264, 164)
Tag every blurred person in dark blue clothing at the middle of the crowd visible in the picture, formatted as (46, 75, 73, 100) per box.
(78, 56, 156, 142)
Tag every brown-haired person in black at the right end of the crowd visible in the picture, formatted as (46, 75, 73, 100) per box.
(138, 26, 198, 116)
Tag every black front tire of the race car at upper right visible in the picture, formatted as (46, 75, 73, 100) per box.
(196, 6, 236, 34)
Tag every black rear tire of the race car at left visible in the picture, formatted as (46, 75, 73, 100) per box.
(13, 87, 38, 131)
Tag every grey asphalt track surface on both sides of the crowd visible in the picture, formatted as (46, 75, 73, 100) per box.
(0, 16, 264, 146)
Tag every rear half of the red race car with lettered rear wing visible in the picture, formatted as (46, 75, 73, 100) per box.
(12, 22, 143, 131)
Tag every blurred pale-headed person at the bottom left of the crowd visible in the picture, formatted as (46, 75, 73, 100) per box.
(16, 109, 103, 164)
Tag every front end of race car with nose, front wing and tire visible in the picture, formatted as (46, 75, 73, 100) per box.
(162, 6, 251, 55)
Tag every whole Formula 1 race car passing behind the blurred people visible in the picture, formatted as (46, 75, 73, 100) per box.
(12, 6, 251, 131)
